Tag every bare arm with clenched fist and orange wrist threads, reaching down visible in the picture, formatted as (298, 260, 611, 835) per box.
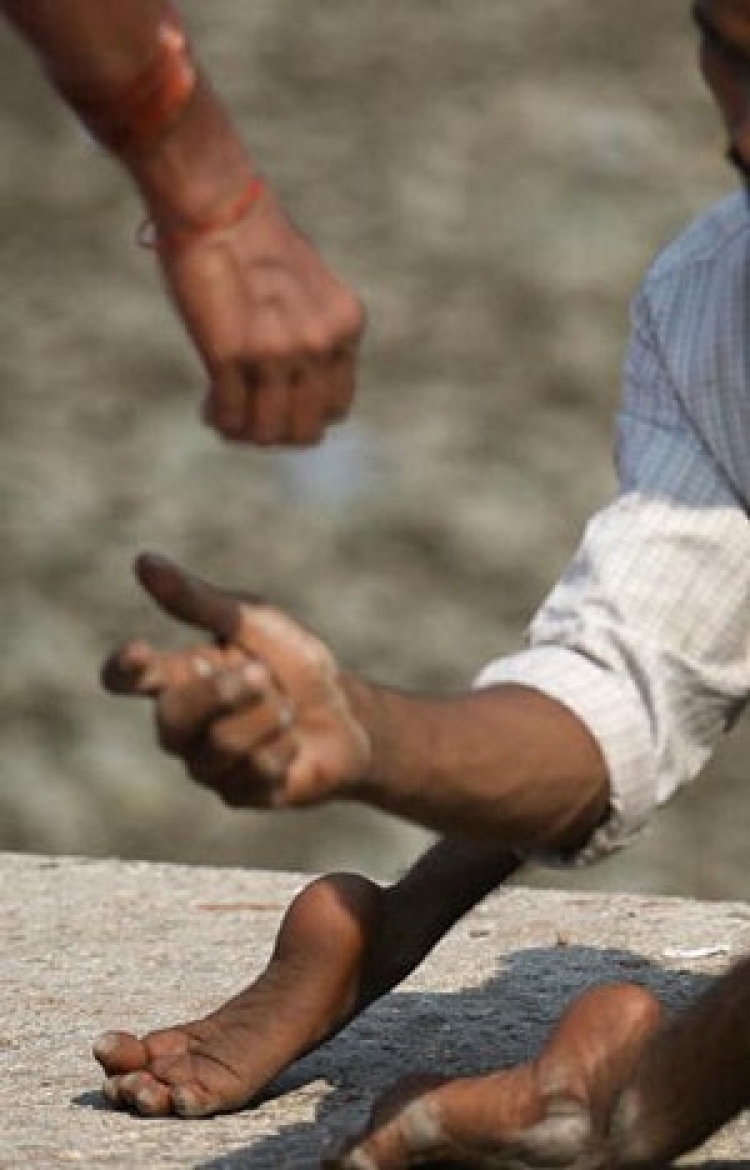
(1, 0, 363, 443)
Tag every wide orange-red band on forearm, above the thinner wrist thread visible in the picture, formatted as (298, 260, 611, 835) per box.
(60, 8, 197, 154)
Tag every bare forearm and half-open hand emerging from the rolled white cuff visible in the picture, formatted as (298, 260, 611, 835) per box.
(104, 557, 607, 853)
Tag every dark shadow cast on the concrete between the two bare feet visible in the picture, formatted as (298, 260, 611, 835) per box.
(184, 947, 711, 1170)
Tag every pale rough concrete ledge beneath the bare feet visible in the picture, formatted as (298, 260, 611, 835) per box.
(0, 854, 750, 1170)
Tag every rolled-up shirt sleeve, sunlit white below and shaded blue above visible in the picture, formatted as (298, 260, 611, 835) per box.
(476, 287, 750, 863)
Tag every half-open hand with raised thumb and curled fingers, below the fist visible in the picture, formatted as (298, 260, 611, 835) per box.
(102, 553, 370, 807)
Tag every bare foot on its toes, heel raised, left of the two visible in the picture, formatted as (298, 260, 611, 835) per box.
(94, 874, 385, 1117)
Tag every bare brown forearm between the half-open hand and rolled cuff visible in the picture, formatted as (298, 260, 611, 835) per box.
(344, 677, 608, 853)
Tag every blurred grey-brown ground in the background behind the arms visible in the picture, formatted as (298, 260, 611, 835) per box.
(0, 0, 750, 897)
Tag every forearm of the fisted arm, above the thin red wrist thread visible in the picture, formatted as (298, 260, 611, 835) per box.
(0, 0, 250, 222)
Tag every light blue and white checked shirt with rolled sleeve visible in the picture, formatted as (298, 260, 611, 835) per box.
(477, 191, 750, 862)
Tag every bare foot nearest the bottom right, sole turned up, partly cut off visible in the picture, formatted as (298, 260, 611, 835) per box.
(324, 984, 660, 1170)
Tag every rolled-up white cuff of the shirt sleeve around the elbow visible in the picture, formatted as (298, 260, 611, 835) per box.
(474, 646, 656, 866)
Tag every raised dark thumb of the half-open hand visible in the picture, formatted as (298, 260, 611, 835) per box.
(136, 552, 242, 641)
